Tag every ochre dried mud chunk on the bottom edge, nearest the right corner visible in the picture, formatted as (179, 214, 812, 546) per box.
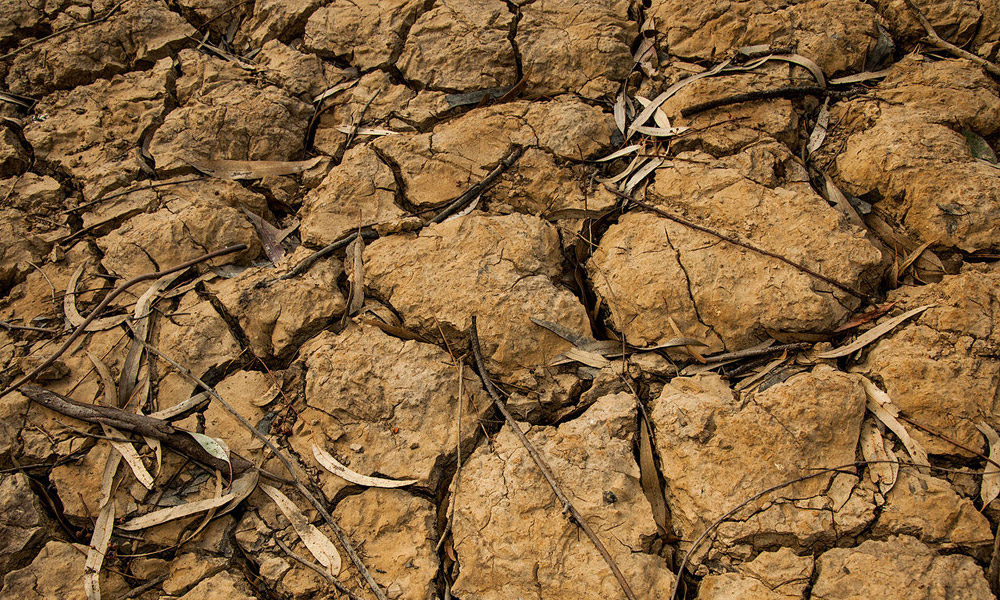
(812, 535, 993, 600)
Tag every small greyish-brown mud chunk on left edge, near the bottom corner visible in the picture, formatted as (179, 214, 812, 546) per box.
(0, 473, 48, 575)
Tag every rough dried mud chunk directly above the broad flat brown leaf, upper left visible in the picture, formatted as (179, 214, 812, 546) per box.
(149, 51, 311, 173)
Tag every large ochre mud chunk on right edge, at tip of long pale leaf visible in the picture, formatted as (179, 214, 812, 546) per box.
(857, 266, 1000, 454)
